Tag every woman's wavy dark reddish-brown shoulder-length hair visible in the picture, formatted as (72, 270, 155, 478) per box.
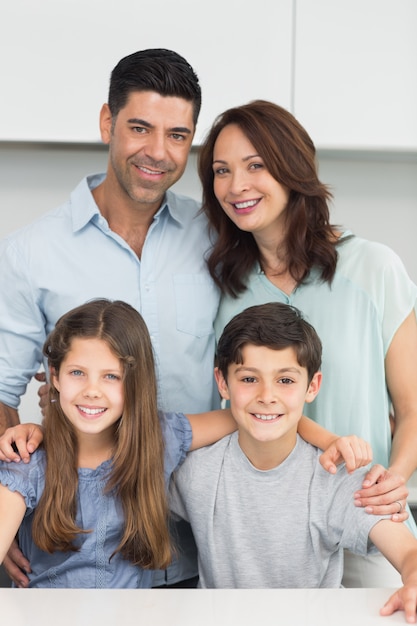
(198, 100, 337, 296)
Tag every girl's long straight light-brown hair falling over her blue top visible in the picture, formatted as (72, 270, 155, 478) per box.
(32, 300, 172, 569)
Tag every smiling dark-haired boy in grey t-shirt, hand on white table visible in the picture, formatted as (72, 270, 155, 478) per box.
(170, 303, 417, 621)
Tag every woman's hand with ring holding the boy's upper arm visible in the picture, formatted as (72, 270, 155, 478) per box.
(355, 465, 409, 522)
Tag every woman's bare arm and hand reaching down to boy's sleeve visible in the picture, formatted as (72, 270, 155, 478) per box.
(356, 311, 417, 521)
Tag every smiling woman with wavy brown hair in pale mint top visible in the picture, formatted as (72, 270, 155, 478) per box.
(199, 101, 417, 587)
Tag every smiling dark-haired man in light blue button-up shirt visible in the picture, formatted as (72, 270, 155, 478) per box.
(0, 49, 219, 586)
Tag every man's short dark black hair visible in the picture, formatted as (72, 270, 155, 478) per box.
(108, 48, 201, 125)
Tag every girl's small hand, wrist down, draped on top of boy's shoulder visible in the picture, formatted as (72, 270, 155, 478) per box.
(320, 435, 372, 474)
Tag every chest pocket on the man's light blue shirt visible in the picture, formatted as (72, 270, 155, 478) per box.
(174, 274, 220, 337)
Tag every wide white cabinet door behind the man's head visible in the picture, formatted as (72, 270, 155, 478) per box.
(0, 0, 294, 144)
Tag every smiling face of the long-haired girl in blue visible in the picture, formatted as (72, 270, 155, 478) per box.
(52, 337, 124, 435)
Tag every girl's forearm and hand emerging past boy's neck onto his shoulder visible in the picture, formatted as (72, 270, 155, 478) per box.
(298, 415, 372, 474)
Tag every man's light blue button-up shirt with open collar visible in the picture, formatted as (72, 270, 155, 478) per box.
(0, 174, 219, 413)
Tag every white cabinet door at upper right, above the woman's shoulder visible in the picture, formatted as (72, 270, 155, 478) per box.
(294, 0, 417, 150)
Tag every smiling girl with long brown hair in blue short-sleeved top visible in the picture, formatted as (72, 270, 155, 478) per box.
(0, 300, 235, 588)
